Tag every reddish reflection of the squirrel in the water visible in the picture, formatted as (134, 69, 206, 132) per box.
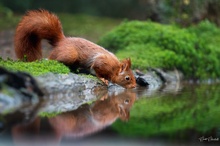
(12, 90, 136, 142)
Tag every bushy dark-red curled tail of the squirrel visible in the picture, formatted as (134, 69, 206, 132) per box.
(14, 9, 65, 61)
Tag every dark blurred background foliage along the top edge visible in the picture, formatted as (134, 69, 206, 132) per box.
(0, 0, 220, 26)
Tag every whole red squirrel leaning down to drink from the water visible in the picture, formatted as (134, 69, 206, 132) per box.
(14, 9, 136, 88)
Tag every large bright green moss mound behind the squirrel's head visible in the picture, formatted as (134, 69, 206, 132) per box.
(99, 21, 220, 79)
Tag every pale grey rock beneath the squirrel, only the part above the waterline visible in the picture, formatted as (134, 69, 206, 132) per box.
(36, 73, 104, 95)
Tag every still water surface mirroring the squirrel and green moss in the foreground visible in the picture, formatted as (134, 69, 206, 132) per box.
(0, 84, 220, 146)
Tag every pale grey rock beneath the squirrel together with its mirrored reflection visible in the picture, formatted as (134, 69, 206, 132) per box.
(36, 73, 107, 113)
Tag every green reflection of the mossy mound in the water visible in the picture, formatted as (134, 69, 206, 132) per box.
(112, 86, 220, 137)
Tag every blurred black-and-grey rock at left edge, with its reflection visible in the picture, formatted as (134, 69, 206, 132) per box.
(0, 67, 43, 113)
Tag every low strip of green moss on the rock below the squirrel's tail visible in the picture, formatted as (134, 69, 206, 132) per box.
(0, 59, 70, 76)
